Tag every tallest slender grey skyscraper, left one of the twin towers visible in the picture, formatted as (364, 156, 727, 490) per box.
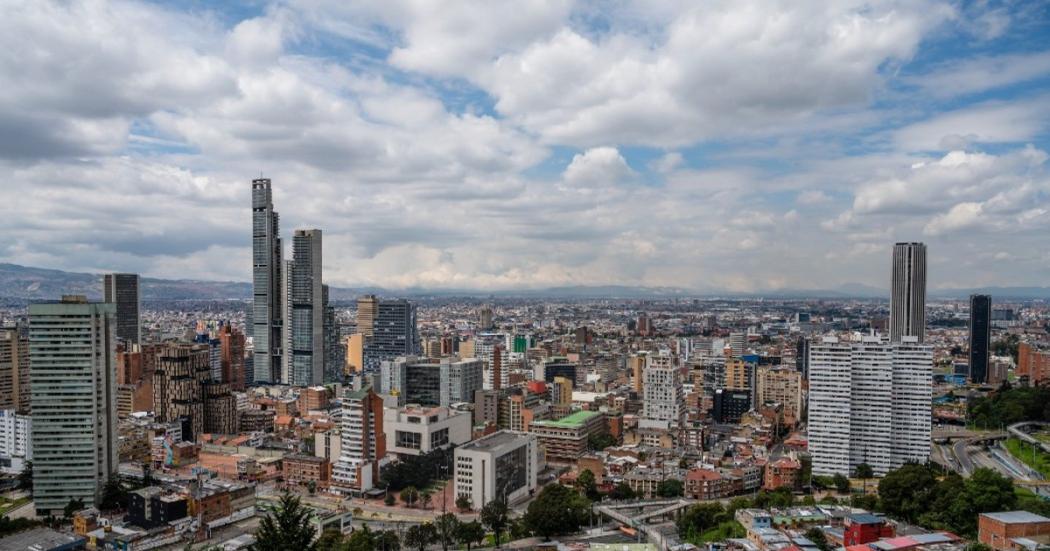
(252, 178, 284, 383)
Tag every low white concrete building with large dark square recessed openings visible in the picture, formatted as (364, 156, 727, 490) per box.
(383, 406, 471, 455)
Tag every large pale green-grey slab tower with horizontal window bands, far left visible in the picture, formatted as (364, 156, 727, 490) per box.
(29, 296, 118, 516)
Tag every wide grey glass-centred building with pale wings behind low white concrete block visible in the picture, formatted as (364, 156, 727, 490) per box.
(380, 356, 482, 407)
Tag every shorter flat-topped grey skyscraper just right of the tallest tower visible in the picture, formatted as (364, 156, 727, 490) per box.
(287, 230, 326, 386)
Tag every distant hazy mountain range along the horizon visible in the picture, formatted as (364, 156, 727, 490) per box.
(0, 263, 1050, 301)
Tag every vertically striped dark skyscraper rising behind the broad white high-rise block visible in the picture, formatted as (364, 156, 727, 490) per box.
(889, 242, 926, 342)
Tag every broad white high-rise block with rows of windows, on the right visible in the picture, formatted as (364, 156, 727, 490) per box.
(809, 336, 933, 474)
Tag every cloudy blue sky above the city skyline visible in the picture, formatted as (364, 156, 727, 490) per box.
(0, 0, 1050, 292)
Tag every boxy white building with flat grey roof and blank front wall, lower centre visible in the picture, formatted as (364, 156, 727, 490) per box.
(455, 430, 543, 509)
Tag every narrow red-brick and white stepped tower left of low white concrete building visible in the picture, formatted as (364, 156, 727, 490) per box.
(332, 388, 386, 494)
